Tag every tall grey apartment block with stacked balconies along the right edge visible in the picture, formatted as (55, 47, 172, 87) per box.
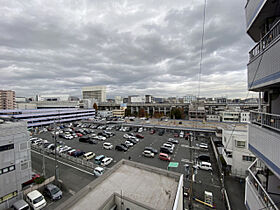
(245, 0, 280, 209)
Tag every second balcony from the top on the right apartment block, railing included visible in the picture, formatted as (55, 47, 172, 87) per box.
(247, 21, 280, 90)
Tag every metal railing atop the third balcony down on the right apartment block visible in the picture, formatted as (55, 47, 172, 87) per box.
(250, 111, 280, 132)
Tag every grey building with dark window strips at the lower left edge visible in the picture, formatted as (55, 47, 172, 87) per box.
(0, 118, 32, 209)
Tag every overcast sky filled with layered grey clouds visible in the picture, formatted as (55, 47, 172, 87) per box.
(0, 0, 254, 98)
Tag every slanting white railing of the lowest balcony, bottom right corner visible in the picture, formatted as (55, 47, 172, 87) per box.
(248, 159, 278, 210)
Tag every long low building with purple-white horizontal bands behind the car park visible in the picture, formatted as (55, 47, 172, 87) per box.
(0, 109, 95, 127)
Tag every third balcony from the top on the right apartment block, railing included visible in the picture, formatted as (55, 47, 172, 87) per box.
(248, 111, 280, 179)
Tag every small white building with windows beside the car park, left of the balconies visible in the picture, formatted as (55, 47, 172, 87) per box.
(222, 124, 256, 178)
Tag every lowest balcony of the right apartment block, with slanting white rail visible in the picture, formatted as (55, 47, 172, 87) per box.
(245, 160, 279, 210)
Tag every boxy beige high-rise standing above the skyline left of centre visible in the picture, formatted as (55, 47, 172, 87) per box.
(82, 86, 106, 102)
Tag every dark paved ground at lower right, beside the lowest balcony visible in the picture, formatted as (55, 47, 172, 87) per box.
(225, 176, 247, 210)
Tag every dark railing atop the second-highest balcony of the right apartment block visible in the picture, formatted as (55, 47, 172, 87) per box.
(249, 20, 280, 61)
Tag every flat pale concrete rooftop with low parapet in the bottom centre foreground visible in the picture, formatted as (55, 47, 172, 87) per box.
(57, 159, 183, 210)
